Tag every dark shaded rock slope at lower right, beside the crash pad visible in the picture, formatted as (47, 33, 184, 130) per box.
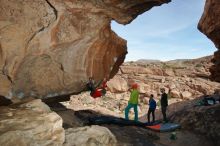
(169, 101, 220, 145)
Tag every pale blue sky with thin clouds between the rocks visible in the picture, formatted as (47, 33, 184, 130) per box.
(111, 0, 217, 61)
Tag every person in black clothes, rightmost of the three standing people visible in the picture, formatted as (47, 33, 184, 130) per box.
(160, 88, 168, 122)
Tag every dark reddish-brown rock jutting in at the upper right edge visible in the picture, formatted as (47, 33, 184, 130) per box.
(198, 0, 220, 82)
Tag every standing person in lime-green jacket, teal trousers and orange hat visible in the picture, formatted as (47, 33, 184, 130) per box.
(125, 84, 139, 122)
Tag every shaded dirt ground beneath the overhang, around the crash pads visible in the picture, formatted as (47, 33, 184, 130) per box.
(47, 103, 217, 146)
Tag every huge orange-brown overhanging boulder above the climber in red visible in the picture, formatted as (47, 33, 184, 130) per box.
(0, 0, 170, 98)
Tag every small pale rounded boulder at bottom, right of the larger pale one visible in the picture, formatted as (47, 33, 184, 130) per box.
(64, 125, 117, 146)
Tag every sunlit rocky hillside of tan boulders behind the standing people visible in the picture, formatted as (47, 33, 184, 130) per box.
(108, 56, 220, 100)
